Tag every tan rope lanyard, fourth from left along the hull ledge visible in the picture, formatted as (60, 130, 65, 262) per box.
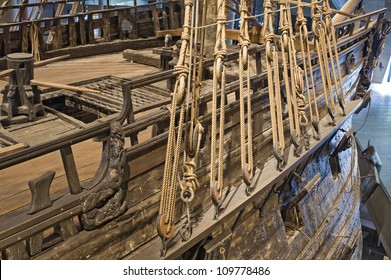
(238, 0, 254, 194)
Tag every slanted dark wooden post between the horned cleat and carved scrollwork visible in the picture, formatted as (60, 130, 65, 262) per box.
(60, 146, 81, 194)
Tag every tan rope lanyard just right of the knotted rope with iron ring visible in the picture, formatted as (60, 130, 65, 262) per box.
(210, 0, 227, 219)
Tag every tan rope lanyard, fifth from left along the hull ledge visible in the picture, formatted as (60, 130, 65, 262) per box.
(263, 0, 285, 170)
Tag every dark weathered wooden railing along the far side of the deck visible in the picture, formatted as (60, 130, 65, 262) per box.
(0, 0, 181, 57)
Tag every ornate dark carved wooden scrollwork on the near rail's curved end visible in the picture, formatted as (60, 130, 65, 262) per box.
(81, 122, 129, 230)
